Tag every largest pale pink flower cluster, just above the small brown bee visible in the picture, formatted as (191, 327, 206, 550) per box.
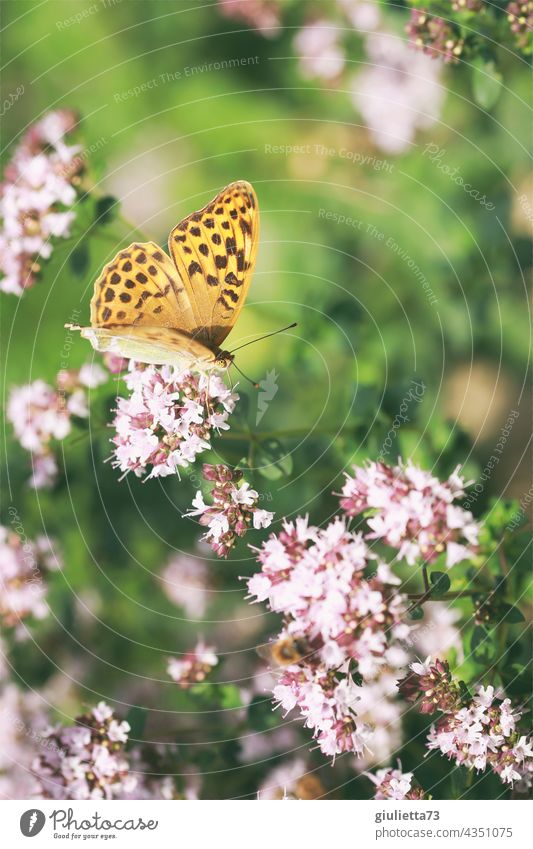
(248, 518, 409, 678)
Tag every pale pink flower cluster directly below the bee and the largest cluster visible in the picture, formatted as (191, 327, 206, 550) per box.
(273, 664, 371, 758)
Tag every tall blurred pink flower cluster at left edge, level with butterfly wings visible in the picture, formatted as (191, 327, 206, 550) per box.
(0, 110, 83, 295)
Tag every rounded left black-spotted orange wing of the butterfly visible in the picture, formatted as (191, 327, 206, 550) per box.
(91, 242, 194, 332)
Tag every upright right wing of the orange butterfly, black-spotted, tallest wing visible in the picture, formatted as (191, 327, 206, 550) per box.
(169, 181, 259, 348)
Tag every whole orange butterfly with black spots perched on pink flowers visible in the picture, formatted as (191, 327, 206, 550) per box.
(67, 181, 259, 370)
